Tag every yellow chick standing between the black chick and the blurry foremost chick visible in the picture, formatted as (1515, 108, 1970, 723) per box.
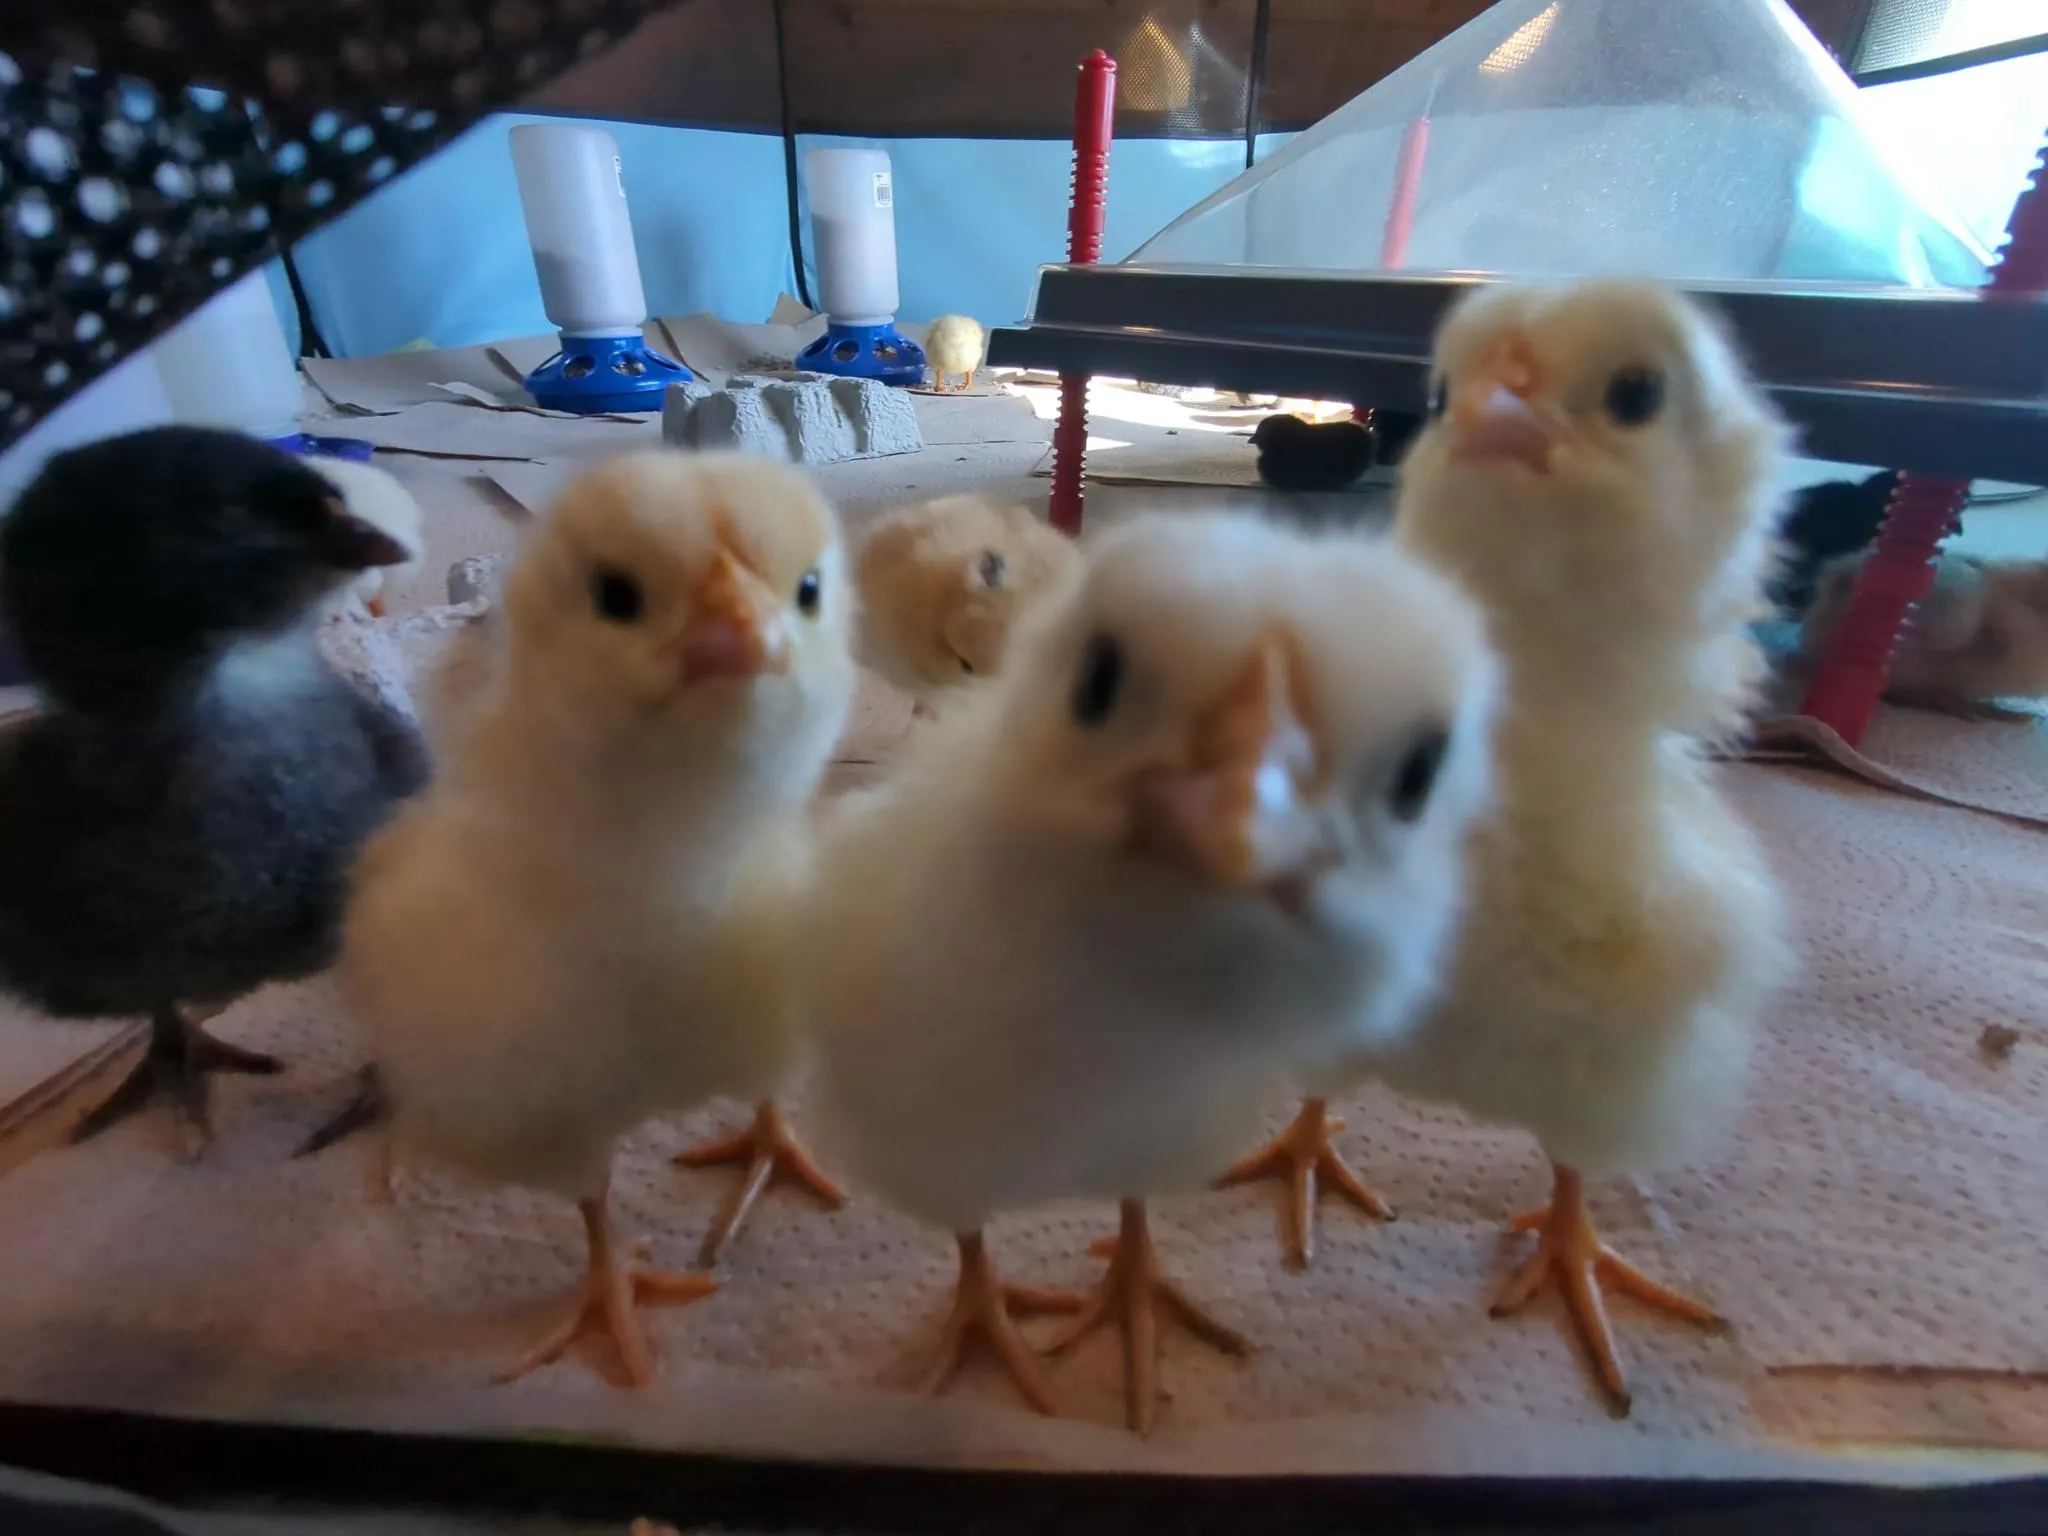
(340, 453, 854, 1384)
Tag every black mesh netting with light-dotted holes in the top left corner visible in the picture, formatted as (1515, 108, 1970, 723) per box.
(0, 0, 668, 446)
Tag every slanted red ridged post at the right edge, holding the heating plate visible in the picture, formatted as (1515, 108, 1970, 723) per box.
(1800, 145, 2048, 748)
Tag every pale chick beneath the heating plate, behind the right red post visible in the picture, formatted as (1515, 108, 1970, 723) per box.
(1802, 555, 2048, 721)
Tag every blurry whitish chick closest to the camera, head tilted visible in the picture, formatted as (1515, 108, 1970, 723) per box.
(809, 516, 1493, 1430)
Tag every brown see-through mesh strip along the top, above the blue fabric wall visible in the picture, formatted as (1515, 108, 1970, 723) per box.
(479, 0, 1900, 139)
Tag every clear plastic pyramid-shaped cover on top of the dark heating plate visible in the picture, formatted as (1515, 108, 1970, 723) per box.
(1130, 0, 1989, 287)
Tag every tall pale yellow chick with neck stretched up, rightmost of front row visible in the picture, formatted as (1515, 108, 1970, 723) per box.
(1386, 283, 1790, 1411)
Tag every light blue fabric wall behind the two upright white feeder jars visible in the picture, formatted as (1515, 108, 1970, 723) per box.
(279, 115, 1284, 356)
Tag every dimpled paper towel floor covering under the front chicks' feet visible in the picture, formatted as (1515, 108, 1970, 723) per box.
(0, 604, 2048, 1475)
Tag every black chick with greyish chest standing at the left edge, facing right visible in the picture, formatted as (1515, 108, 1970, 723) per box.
(0, 426, 426, 1153)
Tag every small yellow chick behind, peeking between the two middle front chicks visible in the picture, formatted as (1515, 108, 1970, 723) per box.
(854, 496, 1081, 713)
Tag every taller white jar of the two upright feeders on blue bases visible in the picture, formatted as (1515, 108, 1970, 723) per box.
(512, 123, 647, 336)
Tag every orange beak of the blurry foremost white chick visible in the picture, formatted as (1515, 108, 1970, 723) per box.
(1135, 631, 1333, 891)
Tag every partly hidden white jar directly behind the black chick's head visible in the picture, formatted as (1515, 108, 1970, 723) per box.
(150, 266, 305, 438)
